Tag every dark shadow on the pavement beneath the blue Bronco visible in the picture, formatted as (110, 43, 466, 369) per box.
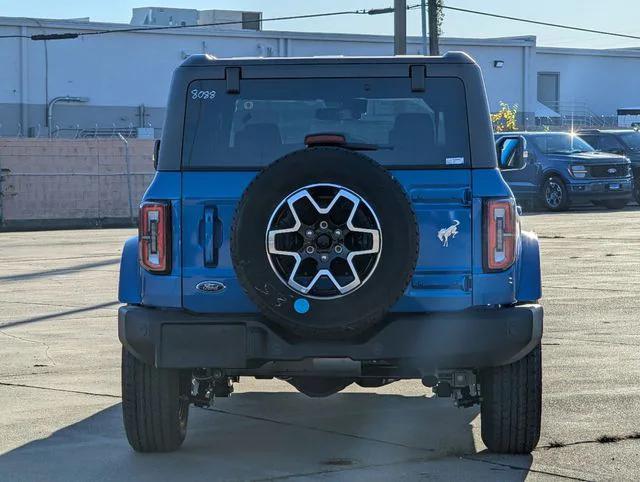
(0, 392, 531, 481)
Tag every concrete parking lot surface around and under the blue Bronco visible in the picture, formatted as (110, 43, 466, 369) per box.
(0, 208, 640, 481)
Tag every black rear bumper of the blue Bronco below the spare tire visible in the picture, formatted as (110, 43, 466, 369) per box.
(118, 304, 543, 374)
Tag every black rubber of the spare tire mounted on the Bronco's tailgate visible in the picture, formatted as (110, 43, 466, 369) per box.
(231, 147, 419, 339)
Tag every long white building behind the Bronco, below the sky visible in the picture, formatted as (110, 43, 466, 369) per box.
(0, 9, 640, 136)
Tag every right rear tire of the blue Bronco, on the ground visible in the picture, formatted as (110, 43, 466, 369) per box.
(480, 345, 542, 454)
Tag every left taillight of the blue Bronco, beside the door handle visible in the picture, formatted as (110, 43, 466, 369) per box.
(138, 202, 171, 274)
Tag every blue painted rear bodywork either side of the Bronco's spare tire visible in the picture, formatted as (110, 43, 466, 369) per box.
(120, 169, 540, 313)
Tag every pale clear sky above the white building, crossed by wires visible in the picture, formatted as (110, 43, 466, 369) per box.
(0, 0, 640, 48)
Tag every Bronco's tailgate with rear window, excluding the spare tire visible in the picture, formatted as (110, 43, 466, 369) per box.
(181, 64, 472, 312)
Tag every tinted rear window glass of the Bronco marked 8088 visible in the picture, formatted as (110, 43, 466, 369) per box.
(182, 78, 470, 169)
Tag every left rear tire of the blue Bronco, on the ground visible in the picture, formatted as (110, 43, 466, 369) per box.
(122, 348, 190, 452)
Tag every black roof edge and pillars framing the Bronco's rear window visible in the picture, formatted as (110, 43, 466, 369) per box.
(158, 52, 497, 171)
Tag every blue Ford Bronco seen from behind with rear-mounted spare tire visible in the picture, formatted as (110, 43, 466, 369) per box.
(118, 53, 543, 453)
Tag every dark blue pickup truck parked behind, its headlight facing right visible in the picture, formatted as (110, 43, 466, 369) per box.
(496, 132, 633, 211)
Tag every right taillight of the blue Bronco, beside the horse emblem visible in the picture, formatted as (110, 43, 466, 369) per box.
(484, 199, 518, 271)
